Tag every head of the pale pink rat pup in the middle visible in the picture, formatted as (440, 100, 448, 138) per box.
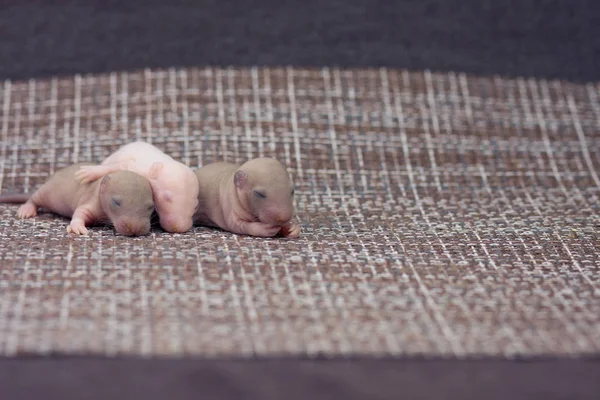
(150, 162, 199, 233)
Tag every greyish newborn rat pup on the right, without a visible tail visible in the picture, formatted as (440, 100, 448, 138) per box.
(194, 157, 300, 238)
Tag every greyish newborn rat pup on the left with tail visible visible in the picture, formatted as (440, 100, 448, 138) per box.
(0, 164, 154, 236)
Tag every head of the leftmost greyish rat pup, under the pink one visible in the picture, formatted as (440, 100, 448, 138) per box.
(100, 171, 154, 236)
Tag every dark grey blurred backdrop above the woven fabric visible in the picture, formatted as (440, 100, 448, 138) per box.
(0, 0, 600, 81)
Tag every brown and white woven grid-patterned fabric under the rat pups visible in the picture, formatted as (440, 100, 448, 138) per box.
(0, 68, 600, 356)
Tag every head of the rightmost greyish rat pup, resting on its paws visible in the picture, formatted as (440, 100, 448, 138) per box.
(233, 157, 294, 226)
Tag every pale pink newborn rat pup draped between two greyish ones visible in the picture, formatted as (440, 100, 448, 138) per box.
(75, 142, 198, 233)
